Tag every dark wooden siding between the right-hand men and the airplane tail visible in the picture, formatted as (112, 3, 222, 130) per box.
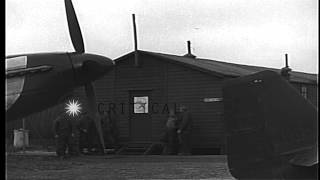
(167, 58, 225, 148)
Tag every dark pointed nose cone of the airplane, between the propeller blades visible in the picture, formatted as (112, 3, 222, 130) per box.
(70, 53, 114, 85)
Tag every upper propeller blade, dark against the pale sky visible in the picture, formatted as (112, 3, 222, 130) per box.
(64, 0, 84, 53)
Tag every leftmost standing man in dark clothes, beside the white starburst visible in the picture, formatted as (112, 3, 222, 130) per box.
(53, 112, 72, 159)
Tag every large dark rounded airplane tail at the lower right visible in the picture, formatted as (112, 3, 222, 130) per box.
(223, 71, 318, 178)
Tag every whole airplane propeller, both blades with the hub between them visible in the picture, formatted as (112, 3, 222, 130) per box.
(64, 0, 107, 149)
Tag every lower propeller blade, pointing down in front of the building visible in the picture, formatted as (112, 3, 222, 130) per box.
(85, 83, 105, 150)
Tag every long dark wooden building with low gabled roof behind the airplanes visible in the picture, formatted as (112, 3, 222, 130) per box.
(5, 51, 318, 154)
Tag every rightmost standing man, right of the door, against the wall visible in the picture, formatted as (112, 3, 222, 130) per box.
(177, 105, 192, 155)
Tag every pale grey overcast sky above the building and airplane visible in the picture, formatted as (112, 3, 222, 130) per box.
(5, 0, 319, 73)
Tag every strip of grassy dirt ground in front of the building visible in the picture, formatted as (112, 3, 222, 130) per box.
(6, 153, 234, 180)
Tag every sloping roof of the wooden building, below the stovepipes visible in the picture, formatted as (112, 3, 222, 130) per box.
(116, 50, 318, 84)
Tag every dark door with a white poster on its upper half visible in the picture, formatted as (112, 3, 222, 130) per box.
(129, 90, 152, 141)
